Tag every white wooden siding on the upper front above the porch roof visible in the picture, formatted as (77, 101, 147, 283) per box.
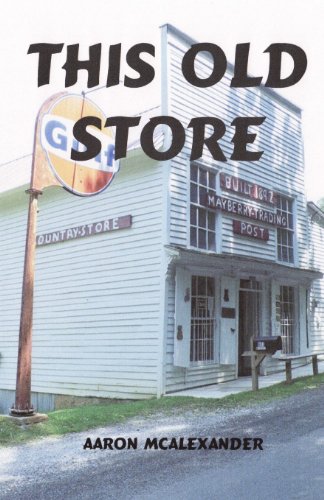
(167, 28, 307, 267)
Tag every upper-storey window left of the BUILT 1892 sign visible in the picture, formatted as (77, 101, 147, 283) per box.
(190, 163, 216, 251)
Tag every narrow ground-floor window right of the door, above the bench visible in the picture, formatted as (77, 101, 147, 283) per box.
(280, 286, 295, 354)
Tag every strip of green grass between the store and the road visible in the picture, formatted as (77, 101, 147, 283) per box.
(0, 373, 324, 446)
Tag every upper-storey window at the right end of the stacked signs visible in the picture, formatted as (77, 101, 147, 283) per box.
(277, 196, 294, 263)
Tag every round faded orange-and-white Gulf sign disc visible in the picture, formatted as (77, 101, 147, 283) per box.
(41, 95, 119, 196)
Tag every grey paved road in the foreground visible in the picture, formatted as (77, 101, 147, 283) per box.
(0, 388, 324, 500)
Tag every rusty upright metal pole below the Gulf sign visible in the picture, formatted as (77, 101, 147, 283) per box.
(10, 189, 42, 417)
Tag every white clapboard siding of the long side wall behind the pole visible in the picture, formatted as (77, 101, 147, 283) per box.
(0, 156, 163, 398)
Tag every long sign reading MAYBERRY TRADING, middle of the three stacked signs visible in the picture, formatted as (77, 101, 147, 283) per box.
(201, 193, 287, 227)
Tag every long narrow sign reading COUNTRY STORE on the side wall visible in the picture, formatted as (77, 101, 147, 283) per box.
(36, 215, 132, 246)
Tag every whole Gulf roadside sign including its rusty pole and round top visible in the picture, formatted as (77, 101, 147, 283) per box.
(10, 93, 116, 421)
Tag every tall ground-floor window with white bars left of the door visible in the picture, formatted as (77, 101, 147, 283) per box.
(190, 276, 215, 362)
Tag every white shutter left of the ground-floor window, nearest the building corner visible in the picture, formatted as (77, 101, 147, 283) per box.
(174, 267, 191, 368)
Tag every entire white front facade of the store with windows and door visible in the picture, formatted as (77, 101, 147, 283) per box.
(165, 27, 321, 390)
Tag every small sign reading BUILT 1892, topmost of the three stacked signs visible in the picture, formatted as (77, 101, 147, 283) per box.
(220, 173, 277, 205)
